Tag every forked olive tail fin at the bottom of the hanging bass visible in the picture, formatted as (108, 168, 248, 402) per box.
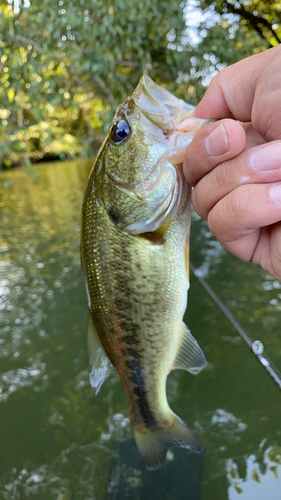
(132, 413, 203, 470)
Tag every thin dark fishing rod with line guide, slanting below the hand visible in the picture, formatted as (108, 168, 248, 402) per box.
(190, 262, 281, 390)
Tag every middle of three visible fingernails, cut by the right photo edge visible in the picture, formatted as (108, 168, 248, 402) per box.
(249, 141, 281, 172)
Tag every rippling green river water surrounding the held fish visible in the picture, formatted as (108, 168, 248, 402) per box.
(0, 161, 281, 500)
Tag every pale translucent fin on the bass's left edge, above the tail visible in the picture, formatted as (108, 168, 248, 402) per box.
(88, 314, 113, 395)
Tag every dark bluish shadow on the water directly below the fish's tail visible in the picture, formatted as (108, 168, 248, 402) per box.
(104, 439, 204, 500)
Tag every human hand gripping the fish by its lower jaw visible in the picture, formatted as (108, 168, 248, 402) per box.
(184, 46, 281, 279)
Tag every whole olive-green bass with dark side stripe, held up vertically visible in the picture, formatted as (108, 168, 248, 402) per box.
(81, 75, 207, 469)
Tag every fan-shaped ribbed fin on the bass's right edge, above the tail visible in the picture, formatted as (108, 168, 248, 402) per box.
(172, 323, 207, 375)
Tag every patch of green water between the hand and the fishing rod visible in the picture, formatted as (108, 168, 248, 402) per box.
(191, 215, 281, 372)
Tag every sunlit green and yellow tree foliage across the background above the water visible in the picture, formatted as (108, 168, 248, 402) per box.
(0, 0, 281, 167)
